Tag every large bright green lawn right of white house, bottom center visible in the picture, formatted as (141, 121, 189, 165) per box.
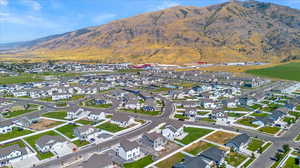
(177, 127, 213, 144)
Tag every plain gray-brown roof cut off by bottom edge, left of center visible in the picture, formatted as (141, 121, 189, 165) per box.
(80, 154, 113, 168)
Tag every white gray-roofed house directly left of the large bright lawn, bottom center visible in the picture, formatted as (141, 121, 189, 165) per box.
(162, 123, 184, 141)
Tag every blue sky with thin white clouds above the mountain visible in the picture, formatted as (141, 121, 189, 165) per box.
(0, 0, 300, 43)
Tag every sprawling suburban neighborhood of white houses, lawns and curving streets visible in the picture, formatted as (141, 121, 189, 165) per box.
(0, 63, 300, 168)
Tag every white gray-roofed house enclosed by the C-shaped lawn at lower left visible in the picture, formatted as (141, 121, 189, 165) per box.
(35, 135, 67, 153)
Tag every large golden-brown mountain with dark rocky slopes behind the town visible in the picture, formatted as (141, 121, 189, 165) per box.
(0, 0, 300, 64)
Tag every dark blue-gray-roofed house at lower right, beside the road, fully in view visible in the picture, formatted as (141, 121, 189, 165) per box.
(225, 134, 250, 152)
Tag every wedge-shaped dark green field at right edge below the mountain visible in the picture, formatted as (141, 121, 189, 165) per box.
(246, 62, 300, 81)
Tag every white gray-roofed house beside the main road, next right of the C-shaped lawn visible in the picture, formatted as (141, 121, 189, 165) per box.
(73, 125, 99, 142)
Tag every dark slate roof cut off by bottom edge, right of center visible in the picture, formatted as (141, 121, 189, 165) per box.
(173, 156, 208, 168)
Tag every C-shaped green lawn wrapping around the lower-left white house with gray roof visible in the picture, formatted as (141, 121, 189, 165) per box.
(24, 131, 60, 160)
